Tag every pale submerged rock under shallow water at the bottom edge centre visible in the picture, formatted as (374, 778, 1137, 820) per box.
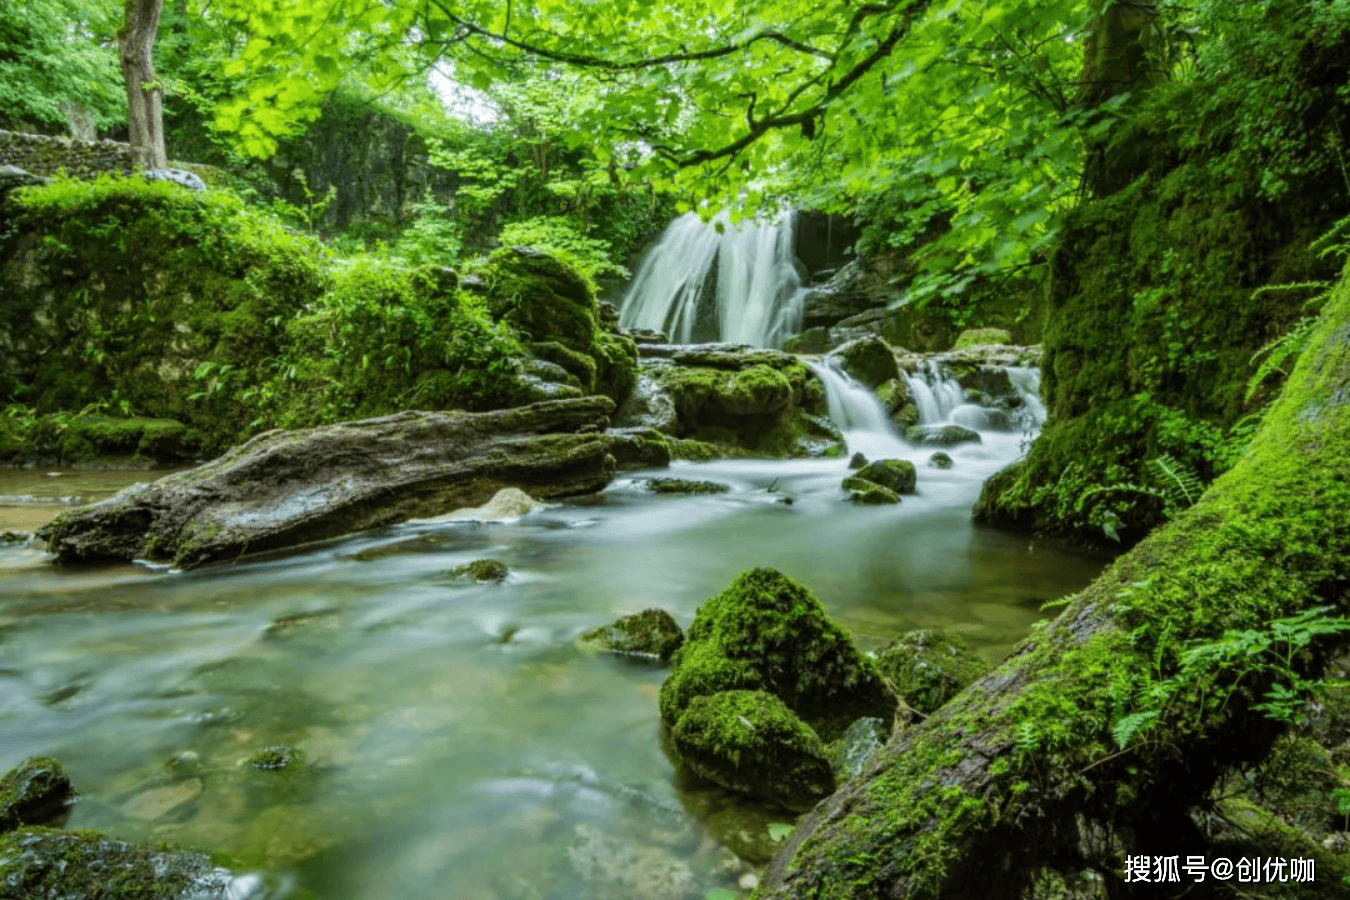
(567, 824, 701, 900)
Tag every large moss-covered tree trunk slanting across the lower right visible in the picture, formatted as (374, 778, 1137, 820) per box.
(756, 265, 1350, 900)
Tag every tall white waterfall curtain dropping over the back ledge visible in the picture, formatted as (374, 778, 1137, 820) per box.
(618, 212, 805, 347)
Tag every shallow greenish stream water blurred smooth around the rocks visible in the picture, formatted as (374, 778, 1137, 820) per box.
(0, 433, 1102, 900)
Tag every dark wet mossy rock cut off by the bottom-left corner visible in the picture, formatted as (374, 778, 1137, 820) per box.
(0, 828, 245, 900)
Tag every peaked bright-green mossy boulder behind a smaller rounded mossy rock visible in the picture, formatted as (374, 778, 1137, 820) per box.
(660, 568, 895, 739)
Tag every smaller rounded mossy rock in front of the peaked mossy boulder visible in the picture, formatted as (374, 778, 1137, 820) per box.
(671, 691, 834, 811)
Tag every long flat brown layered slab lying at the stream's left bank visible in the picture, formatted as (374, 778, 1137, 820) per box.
(41, 397, 614, 568)
